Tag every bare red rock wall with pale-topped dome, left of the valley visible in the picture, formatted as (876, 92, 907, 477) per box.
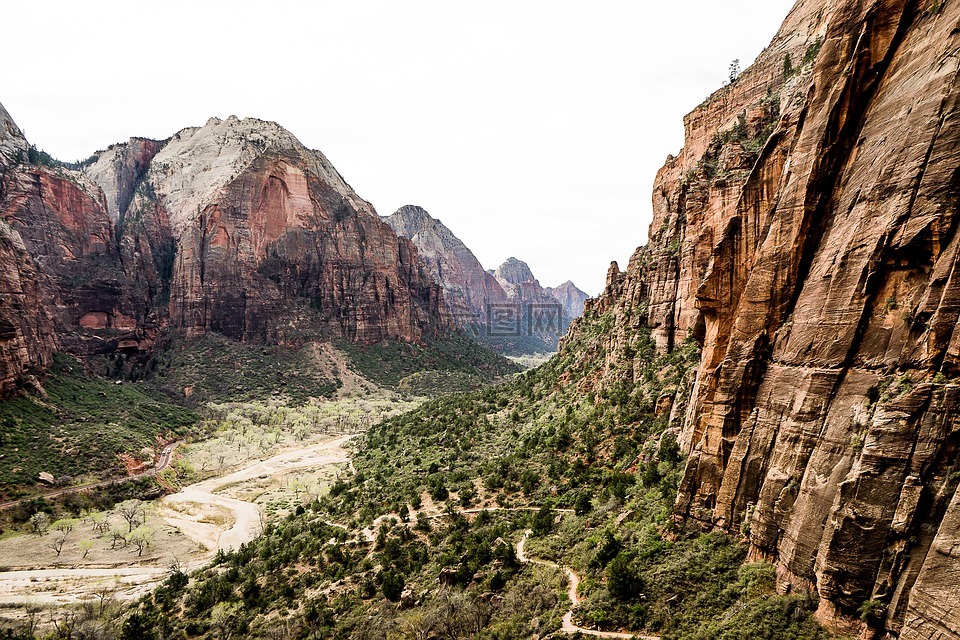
(0, 109, 451, 393)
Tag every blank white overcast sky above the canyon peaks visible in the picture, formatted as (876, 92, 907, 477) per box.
(0, 0, 793, 294)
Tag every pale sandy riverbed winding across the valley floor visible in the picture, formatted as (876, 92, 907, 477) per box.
(0, 434, 353, 618)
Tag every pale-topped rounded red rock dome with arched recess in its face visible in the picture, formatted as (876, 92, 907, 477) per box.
(145, 117, 449, 343)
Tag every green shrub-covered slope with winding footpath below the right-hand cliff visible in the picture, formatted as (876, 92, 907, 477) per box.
(107, 302, 848, 640)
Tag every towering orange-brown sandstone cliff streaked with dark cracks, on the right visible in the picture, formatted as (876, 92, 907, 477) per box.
(564, 0, 960, 638)
